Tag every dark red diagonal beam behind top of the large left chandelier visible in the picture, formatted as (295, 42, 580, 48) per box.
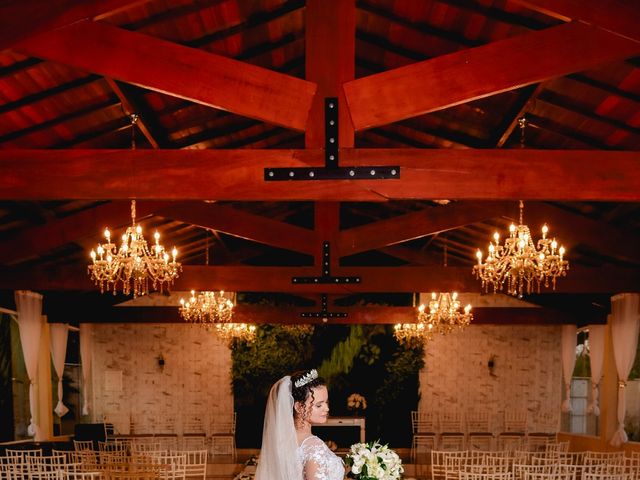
(0, 201, 166, 265)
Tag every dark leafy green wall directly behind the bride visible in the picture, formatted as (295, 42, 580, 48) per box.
(232, 325, 424, 448)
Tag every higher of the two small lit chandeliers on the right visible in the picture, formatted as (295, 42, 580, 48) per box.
(418, 292, 473, 335)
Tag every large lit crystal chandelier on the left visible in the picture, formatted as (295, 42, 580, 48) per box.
(88, 200, 182, 298)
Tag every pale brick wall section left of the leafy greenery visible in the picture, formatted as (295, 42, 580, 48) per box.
(93, 324, 233, 433)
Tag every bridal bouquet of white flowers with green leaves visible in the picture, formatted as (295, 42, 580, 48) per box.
(345, 442, 404, 480)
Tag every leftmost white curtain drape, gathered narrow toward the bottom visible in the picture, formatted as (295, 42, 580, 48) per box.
(15, 290, 43, 437)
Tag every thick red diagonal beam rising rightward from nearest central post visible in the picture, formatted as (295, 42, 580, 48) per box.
(344, 22, 640, 130)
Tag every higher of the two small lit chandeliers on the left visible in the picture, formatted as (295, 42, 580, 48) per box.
(179, 290, 235, 326)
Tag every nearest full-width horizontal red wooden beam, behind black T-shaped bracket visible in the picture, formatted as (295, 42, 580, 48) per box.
(0, 148, 640, 201)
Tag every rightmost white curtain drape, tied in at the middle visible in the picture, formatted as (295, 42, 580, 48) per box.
(611, 293, 640, 447)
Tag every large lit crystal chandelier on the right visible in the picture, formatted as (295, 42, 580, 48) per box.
(473, 200, 569, 298)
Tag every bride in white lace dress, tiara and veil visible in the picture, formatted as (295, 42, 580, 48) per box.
(255, 369, 344, 480)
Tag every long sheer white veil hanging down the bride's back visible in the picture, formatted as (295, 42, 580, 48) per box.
(255, 376, 302, 480)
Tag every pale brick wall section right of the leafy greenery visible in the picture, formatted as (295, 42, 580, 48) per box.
(419, 325, 562, 431)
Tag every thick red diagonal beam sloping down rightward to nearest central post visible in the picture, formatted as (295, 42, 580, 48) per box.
(15, 22, 316, 131)
